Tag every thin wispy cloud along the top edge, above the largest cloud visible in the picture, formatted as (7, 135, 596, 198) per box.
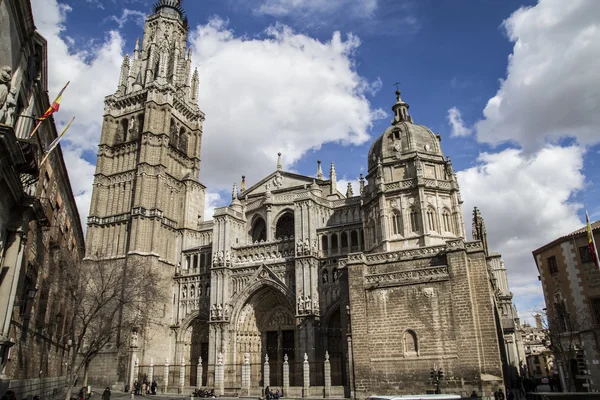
(254, 0, 378, 18)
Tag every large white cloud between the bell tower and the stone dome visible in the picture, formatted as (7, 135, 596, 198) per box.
(191, 18, 382, 190)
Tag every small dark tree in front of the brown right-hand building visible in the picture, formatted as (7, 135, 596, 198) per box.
(541, 300, 590, 392)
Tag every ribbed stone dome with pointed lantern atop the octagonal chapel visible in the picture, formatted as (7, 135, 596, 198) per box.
(369, 91, 444, 170)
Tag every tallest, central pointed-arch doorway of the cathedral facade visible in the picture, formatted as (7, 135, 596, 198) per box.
(235, 285, 296, 387)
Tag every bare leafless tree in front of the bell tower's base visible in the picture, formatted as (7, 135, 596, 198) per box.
(65, 259, 163, 400)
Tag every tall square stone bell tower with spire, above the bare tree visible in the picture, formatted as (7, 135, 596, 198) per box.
(87, 0, 205, 272)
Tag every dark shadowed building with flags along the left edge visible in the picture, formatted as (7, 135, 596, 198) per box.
(0, 0, 84, 398)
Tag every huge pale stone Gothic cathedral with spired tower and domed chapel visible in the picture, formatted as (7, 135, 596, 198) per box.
(86, 0, 505, 398)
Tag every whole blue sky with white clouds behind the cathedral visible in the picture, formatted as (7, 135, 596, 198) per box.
(32, 0, 600, 316)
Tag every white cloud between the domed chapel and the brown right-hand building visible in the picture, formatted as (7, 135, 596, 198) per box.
(458, 146, 585, 310)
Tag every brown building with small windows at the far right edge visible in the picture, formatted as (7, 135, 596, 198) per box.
(533, 221, 600, 392)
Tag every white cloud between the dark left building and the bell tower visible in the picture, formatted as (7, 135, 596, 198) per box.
(32, 0, 123, 229)
